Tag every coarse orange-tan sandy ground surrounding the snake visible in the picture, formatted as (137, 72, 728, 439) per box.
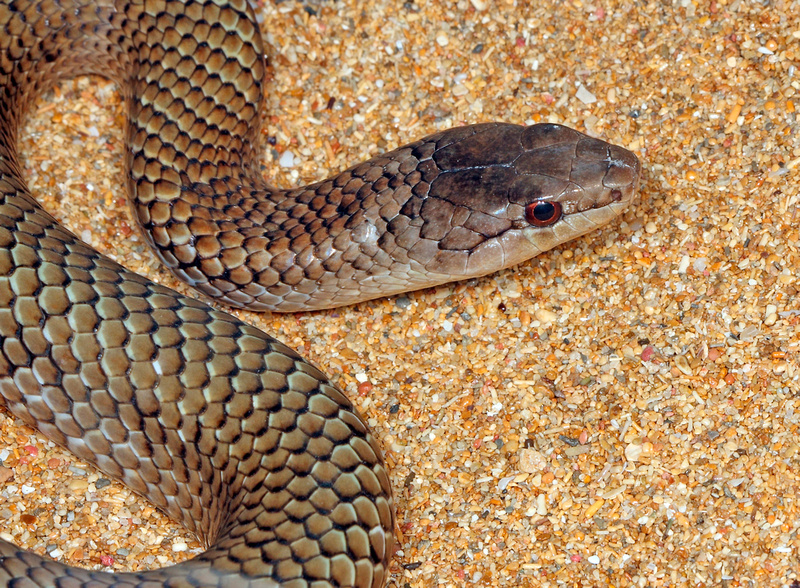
(0, 0, 800, 588)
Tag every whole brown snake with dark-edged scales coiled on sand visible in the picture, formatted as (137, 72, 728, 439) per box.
(0, 0, 640, 588)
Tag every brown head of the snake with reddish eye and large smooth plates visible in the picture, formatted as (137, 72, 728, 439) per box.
(400, 124, 640, 281)
